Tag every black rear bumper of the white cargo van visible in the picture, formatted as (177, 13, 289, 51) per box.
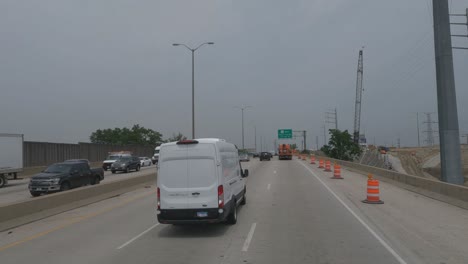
(158, 203, 232, 224)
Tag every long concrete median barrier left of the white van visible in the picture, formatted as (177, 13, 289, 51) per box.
(0, 172, 156, 231)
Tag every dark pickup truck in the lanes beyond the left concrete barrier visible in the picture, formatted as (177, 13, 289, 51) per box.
(29, 162, 104, 197)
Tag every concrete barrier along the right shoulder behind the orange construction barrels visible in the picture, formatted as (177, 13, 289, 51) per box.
(318, 158, 468, 209)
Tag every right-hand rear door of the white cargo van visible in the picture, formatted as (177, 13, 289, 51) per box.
(187, 143, 220, 209)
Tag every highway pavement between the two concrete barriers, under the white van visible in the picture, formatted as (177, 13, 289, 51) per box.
(0, 158, 468, 264)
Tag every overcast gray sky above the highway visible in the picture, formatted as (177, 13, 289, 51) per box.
(0, 0, 468, 148)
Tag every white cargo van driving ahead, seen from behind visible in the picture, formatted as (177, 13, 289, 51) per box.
(157, 139, 249, 224)
